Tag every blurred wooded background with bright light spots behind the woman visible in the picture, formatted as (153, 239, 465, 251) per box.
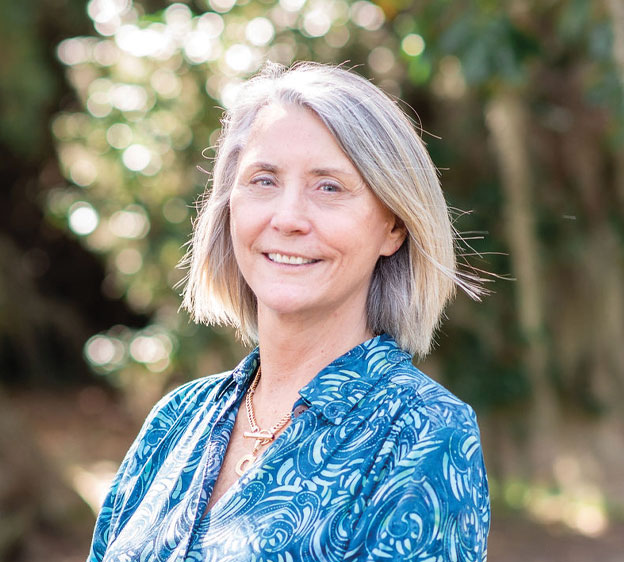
(0, 0, 624, 562)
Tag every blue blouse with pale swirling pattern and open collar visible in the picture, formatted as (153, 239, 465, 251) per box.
(88, 335, 490, 562)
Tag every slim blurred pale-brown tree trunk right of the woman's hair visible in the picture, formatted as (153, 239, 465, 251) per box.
(486, 92, 557, 480)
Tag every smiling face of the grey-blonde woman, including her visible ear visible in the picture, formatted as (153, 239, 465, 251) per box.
(230, 104, 404, 321)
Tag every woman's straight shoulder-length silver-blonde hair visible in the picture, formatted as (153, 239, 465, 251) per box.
(178, 63, 480, 356)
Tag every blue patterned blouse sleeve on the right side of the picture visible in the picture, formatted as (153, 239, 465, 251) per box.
(346, 422, 490, 562)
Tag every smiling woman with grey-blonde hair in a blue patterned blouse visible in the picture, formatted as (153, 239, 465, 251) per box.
(89, 63, 489, 562)
